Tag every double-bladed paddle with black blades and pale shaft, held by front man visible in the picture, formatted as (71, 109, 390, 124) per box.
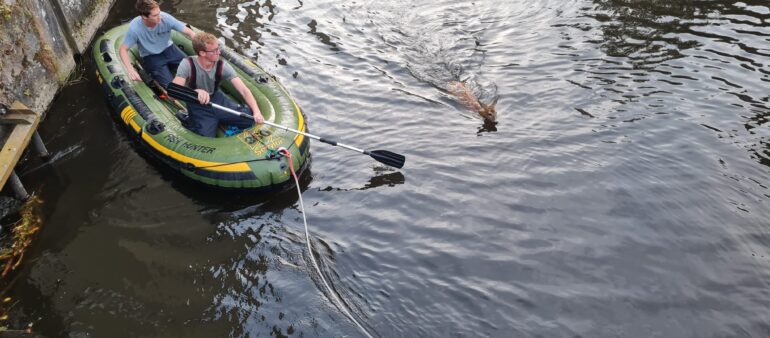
(166, 82, 406, 169)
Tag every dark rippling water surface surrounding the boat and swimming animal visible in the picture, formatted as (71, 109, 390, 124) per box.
(6, 0, 770, 337)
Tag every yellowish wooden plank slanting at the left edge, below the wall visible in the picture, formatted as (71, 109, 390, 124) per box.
(0, 102, 40, 187)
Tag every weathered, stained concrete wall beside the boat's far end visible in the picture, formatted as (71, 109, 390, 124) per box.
(0, 0, 114, 113)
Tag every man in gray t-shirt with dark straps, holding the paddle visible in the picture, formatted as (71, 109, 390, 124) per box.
(173, 32, 264, 137)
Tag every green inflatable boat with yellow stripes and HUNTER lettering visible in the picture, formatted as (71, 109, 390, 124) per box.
(93, 24, 310, 190)
